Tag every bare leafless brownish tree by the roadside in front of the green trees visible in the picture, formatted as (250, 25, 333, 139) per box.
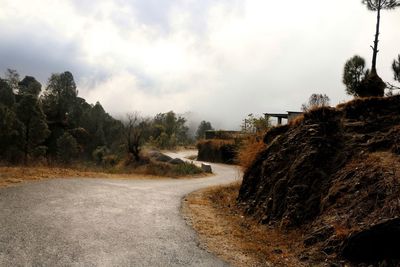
(125, 112, 148, 161)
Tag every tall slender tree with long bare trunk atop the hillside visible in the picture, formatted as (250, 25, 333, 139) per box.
(361, 0, 400, 75)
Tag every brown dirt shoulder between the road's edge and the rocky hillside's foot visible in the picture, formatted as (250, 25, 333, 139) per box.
(182, 183, 307, 266)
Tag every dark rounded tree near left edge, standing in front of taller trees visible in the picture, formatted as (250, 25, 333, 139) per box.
(16, 94, 50, 164)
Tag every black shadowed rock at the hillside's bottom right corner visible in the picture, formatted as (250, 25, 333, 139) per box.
(342, 218, 400, 262)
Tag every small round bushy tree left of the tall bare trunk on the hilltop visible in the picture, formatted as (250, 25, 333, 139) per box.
(343, 55, 369, 96)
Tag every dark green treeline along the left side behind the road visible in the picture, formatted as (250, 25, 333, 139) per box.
(0, 70, 196, 164)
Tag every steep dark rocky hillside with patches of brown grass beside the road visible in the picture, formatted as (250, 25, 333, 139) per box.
(238, 96, 400, 266)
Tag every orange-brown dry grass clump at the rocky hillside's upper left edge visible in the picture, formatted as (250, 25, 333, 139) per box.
(238, 134, 267, 170)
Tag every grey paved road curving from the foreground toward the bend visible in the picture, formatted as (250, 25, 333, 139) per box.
(0, 153, 240, 266)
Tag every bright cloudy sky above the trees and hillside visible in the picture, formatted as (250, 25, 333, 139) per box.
(0, 0, 400, 129)
